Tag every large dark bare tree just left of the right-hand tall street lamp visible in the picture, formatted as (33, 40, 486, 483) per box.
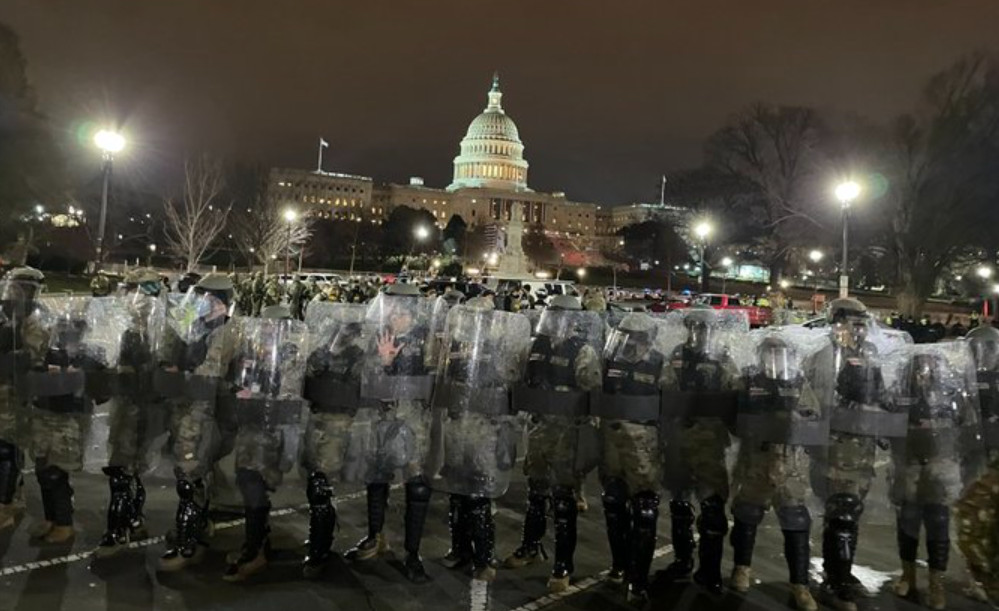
(707, 104, 821, 278)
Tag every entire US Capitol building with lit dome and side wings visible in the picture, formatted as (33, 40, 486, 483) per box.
(268, 75, 684, 262)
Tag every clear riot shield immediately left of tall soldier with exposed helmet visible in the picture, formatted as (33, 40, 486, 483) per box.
(736, 327, 829, 446)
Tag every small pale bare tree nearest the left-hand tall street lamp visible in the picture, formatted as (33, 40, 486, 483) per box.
(163, 155, 232, 271)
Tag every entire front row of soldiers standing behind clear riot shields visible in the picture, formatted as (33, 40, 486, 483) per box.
(0, 268, 999, 611)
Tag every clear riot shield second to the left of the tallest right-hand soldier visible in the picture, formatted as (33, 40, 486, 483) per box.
(662, 308, 751, 428)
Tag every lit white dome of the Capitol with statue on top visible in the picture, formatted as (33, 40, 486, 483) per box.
(448, 75, 529, 191)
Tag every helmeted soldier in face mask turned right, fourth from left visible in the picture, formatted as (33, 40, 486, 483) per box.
(153, 274, 232, 572)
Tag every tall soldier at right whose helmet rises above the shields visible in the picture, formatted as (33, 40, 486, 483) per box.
(806, 298, 906, 611)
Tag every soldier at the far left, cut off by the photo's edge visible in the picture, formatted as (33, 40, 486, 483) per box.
(0, 267, 48, 531)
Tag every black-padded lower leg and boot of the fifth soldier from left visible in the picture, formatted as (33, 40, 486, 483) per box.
(223, 465, 271, 582)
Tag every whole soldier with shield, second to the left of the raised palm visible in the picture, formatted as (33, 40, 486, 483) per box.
(219, 305, 308, 582)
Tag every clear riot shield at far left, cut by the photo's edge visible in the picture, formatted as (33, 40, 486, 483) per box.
(0, 280, 48, 444)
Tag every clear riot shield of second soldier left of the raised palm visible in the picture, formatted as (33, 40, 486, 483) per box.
(218, 318, 309, 487)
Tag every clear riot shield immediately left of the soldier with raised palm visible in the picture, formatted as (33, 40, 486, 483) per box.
(302, 302, 381, 483)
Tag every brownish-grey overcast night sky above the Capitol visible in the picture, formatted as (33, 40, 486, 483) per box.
(0, 0, 999, 203)
